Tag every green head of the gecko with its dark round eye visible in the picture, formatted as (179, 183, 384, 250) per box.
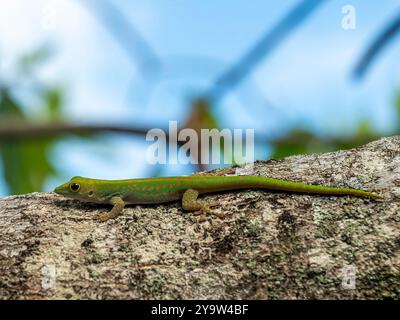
(54, 176, 94, 200)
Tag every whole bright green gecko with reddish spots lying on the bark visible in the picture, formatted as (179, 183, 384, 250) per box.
(54, 175, 382, 221)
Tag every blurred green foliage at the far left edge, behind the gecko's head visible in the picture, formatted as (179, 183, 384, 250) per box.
(0, 48, 63, 194)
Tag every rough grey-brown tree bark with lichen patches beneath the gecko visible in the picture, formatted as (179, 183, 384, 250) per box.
(0, 137, 400, 299)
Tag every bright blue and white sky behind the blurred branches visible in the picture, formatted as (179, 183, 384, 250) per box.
(0, 0, 400, 195)
